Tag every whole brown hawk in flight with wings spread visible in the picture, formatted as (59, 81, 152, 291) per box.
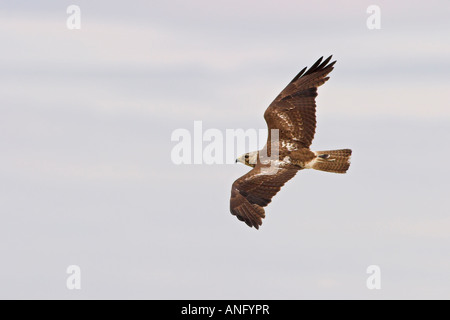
(230, 56, 352, 229)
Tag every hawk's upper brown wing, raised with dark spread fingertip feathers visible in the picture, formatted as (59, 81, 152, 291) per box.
(264, 56, 336, 148)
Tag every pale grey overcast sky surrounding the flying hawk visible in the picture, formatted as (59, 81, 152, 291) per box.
(0, 0, 450, 299)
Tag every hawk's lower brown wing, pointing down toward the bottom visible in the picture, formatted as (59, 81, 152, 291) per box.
(230, 165, 298, 229)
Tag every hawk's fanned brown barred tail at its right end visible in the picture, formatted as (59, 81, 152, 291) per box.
(310, 149, 352, 173)
